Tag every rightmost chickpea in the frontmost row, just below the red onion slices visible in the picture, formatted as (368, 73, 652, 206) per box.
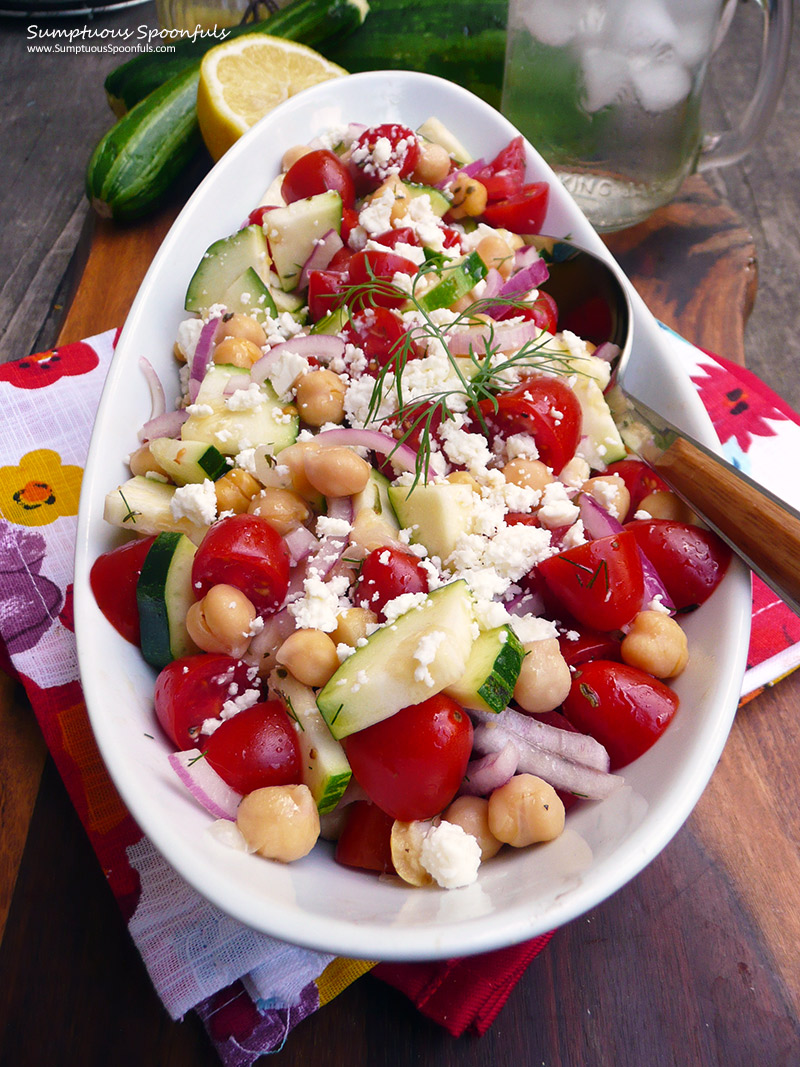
(489, 775, 564, 848)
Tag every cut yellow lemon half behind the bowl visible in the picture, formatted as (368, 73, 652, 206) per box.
(197, 33, 348, 161)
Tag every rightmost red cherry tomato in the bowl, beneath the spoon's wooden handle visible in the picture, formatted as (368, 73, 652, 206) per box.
(625, 519, 731, 610)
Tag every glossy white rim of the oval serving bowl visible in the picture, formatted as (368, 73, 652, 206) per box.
(75, 70, 750, 960)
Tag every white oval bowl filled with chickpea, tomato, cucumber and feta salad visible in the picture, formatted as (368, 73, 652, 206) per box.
(77, 73, 749, 958)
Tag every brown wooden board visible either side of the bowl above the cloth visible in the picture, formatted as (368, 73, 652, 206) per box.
(59, 170, 757, 364)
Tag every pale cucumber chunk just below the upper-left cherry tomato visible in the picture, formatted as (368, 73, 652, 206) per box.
(263, 190, 341, 292)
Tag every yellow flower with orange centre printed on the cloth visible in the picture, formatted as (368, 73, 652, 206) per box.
(0, 448, 83, 526)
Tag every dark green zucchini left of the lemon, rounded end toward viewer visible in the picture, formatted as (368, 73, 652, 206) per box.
(86, 69, 203, 220)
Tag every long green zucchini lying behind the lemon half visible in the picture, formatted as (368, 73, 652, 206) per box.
(105, 0, 369, 115)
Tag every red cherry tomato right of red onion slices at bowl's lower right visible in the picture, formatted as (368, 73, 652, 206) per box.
(562, 659, 678, 770)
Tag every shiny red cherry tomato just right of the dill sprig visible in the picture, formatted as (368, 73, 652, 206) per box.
(476, 377, 582, 474)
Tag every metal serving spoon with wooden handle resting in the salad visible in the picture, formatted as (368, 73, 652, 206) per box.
(535, 238, 800, 615)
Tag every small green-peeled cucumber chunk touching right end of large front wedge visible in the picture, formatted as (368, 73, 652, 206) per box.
(445, 625, 525, 712)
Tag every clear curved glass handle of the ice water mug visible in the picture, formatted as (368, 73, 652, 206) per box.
(697, 0, 793, 171)
